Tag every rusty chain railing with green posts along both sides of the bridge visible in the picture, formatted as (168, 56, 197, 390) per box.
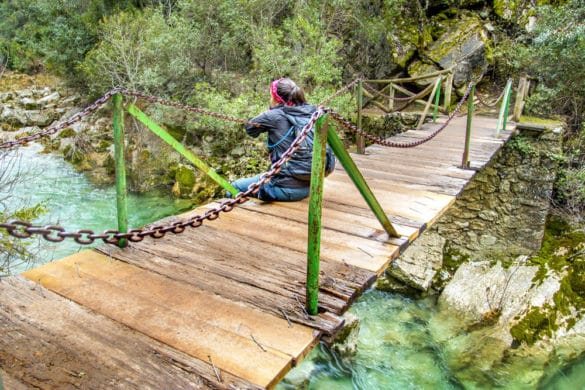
(0, 75, 511, 314)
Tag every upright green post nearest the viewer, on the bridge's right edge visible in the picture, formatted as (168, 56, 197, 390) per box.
(306, 115, 328, 315)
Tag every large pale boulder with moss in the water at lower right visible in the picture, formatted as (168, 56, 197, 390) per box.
(431, 257, 585, 388)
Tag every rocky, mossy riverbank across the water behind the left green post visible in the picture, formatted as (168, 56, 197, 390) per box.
(0, 72, 263, 204)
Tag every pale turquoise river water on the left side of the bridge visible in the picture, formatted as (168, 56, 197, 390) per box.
(0, 144, 191, 272)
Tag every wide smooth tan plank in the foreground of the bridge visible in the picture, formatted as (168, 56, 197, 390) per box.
(23, 251, 316, 387)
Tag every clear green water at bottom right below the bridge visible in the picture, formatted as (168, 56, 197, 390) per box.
(277, 290, 585, 390)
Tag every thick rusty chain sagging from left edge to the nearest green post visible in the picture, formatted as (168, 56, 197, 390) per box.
(0, 106, 325, 245)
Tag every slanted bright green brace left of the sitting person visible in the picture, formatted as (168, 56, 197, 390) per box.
(127, 104, 240, 195)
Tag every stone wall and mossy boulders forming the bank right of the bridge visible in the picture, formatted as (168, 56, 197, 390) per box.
(378, 125, 585, 388)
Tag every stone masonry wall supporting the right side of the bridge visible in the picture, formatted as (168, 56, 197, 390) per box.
(387, 125, 560, 291)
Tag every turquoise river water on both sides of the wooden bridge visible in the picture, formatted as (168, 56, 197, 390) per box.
(0, 145, 585, 390)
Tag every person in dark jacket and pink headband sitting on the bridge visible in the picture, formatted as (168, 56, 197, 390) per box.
(232, 78, 335, 202)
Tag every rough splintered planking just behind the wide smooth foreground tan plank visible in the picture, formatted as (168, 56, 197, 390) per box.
(98, 222, 374, 326)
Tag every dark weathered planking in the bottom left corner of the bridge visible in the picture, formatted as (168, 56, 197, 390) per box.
(0, 276, 257, 390)
